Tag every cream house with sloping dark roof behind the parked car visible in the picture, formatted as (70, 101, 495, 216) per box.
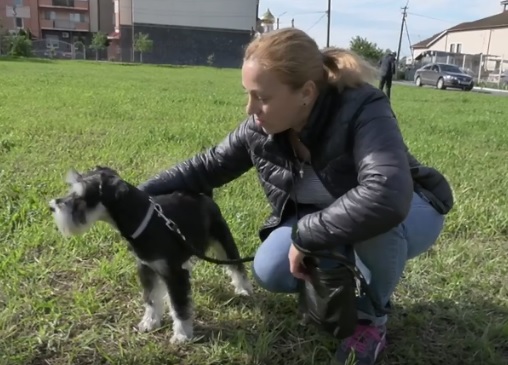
(412, 0, 508, 71)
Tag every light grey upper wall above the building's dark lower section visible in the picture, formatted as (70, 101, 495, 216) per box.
(132, 0, 257, 31)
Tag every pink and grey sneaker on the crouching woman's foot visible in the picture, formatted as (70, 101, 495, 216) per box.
(335, 323, 386, 365)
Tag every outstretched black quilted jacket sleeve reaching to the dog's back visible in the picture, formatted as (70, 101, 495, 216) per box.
(138, 119, 252, 195)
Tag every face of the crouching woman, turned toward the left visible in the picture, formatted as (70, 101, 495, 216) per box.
(242, 60, 313, 134)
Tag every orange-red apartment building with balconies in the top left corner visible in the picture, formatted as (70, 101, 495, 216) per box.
(0, 0, 114, 48)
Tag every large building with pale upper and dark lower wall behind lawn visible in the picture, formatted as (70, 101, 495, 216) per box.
(110, 0, 258, 67)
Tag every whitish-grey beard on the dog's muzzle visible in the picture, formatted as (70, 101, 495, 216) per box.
(50, 200, 111, 237)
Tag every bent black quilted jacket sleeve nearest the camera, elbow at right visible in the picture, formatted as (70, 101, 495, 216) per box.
(292, 92, 413, 252)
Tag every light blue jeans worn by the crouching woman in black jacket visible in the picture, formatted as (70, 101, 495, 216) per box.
(253, 193, 444, 326)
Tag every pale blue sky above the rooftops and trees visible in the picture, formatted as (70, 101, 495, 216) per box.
(259, 0, 503, 57)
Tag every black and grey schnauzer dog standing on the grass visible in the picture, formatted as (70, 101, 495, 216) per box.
(49, 166, 252, 343)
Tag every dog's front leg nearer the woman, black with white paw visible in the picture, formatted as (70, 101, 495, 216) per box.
(165, 267, 194, 343)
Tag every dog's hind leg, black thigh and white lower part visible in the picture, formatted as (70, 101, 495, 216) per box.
(210, 218, 254, 295)
